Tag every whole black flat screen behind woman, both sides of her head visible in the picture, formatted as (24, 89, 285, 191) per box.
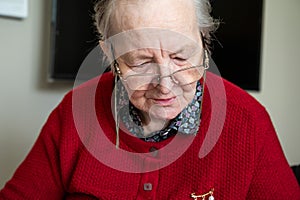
(49, 0, 263, 90)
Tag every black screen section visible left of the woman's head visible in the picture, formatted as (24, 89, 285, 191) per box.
(50, 0, 97, 80)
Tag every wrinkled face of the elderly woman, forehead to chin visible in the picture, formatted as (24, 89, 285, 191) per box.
(106, 0, 203, 124)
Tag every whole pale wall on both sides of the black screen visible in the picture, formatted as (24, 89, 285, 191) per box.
(0, 0, 300, 188)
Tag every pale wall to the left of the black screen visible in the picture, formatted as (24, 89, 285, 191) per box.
(0, 0, 72, 188)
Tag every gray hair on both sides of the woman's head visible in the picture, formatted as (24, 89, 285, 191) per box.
(94, 0, 219, 44)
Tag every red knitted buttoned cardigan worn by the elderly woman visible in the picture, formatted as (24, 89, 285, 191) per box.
(0, 73, 300, 200)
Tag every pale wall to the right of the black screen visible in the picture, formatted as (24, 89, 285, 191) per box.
(251, 0, 300, 165)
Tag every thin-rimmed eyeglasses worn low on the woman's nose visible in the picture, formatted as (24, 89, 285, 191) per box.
(120, 65, 206, 90)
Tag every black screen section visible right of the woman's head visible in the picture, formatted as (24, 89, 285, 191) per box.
(212, 0, 262, 90)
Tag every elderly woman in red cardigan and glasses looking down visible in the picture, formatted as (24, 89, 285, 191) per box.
(0, 0, 300, 200)
